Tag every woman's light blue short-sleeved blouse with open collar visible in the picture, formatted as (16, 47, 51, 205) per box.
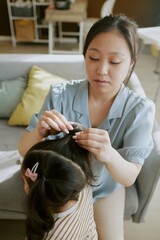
(26, 80, 155, 200)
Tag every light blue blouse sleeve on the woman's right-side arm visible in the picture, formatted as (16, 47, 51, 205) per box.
(117, 99, 155, 164)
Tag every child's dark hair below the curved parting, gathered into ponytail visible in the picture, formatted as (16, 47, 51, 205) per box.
(21, 149, 86, 240)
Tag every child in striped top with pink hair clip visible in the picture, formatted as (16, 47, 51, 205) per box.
(22, 125, 98, 240)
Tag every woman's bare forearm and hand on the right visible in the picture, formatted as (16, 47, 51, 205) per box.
(74, 128, 141, 187)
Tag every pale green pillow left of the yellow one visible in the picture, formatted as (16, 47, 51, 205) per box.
(0, 77, 27, 118)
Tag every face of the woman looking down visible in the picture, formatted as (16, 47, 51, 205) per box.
(85, 31, 131, 95)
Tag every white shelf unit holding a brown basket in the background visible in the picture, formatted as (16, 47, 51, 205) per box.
(7, 0, 51, 46)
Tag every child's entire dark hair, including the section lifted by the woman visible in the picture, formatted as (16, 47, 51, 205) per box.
(21, 123, 95, 240)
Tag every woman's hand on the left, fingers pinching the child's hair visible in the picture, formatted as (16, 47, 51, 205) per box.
(37, 109, 73, 138)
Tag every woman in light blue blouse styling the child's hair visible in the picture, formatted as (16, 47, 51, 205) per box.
(19, 15, 154, 240)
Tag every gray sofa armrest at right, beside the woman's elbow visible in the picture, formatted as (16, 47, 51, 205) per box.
(132, 122, 160, 223)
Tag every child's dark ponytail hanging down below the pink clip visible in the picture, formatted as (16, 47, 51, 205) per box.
(26, 178, 54, 240)
